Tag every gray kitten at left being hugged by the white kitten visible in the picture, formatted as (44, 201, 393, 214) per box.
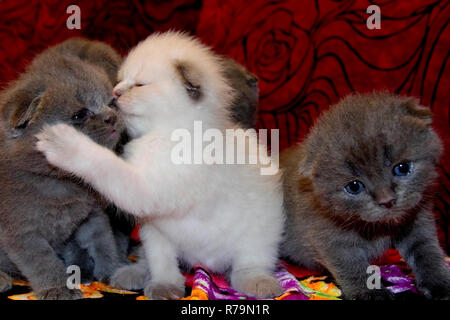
(0, 38, 124, 299)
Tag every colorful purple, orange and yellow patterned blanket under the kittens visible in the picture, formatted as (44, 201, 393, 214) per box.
(0, 250, 450, 300)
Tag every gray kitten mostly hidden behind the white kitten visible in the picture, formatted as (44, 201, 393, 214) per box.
(111, 56, 259, 290)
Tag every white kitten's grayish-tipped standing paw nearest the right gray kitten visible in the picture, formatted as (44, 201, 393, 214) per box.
(233, 274, 283, 298)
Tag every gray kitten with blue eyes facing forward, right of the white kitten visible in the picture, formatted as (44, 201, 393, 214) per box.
(281, 93, 450, 299)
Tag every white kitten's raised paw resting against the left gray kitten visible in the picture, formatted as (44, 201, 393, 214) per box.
(36, 124, 84, 170)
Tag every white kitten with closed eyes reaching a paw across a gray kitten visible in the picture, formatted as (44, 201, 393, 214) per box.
(38, 32, 283, 298)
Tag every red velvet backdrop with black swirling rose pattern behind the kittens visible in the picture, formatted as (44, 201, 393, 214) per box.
(0, 0, 450, 252)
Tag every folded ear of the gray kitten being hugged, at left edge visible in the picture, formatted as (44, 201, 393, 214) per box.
(2, 88, 43, 138)
